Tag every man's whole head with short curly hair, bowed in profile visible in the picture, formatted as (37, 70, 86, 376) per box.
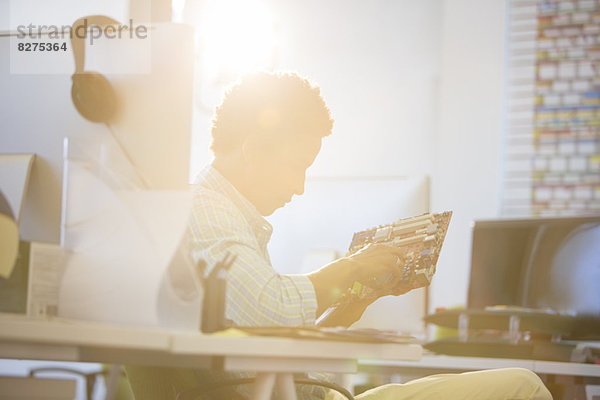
(211, 72, 333, 215)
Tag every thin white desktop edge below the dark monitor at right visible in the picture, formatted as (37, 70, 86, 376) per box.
(359, 355, 600, 377)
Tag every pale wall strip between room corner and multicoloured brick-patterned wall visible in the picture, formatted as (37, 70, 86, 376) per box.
(430, 0, 506, 308)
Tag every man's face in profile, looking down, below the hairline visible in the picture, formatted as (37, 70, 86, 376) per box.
(244, 134, 321, 216)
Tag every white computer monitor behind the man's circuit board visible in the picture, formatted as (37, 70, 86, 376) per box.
(268, 175, 435, 335)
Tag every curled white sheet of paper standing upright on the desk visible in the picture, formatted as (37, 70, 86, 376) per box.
(58, 162, 200, 325)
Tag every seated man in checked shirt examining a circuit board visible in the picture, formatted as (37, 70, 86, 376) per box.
(190, 73, 551, 399)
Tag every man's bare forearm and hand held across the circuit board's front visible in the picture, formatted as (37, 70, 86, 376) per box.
(308, 244, 413, 317)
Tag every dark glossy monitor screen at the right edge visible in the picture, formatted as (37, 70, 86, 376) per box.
(468, 215, 600, 315)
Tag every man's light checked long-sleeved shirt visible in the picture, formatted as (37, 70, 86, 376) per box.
(189, 190, 317, 326)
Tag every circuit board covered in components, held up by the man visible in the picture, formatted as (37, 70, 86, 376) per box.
(345, 211, 452, 300)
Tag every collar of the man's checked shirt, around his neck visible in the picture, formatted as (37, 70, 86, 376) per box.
(196, 165, 273, 242)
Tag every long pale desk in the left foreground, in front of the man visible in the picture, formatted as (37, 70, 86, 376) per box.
(0, 314, 422, 400)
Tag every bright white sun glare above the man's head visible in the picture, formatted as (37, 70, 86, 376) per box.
(200, 0, 275, 80)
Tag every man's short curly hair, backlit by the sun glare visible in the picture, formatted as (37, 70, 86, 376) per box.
(210, 72, 333, 155)
